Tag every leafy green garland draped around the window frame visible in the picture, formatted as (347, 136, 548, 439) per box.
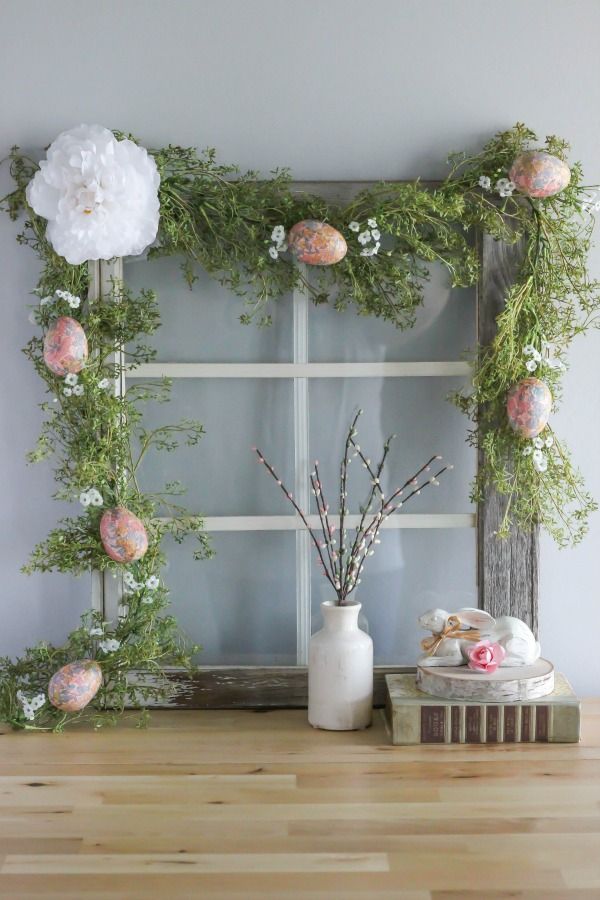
(0, 124, 600, 728)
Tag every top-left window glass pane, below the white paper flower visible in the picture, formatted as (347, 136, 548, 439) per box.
(124, 257, 293, 362)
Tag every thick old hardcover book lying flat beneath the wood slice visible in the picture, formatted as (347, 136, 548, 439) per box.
(385, 672, 581, 745)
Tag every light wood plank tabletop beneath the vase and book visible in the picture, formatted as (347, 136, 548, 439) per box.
(0, 701, 600, 900)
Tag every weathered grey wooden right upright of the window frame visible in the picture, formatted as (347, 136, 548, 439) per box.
(477, 234, 539, 635)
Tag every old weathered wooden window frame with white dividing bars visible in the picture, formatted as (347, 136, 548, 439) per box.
(89, 181, 539, 709)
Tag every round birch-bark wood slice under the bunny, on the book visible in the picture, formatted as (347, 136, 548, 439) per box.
(417, 659, 554, 703)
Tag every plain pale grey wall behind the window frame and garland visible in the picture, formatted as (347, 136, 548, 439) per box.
(0, 0, 600, 694)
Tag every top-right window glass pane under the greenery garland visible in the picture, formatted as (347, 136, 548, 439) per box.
(308, 266, 476, 362)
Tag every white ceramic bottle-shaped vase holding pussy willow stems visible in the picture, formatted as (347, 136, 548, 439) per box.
(308, 600, 373, 731)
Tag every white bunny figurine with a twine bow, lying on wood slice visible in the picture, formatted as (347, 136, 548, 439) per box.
(419, 608, 541, 666)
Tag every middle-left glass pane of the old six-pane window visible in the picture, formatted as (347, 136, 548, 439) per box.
(135, 378, 294, 516)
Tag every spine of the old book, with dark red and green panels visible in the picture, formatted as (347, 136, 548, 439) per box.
(388, 703, 580, 744)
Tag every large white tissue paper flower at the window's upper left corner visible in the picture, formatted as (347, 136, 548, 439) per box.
(26, 125, 160, 265)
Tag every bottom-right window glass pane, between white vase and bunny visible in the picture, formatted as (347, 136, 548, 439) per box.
(311, 528, 478, 666)
